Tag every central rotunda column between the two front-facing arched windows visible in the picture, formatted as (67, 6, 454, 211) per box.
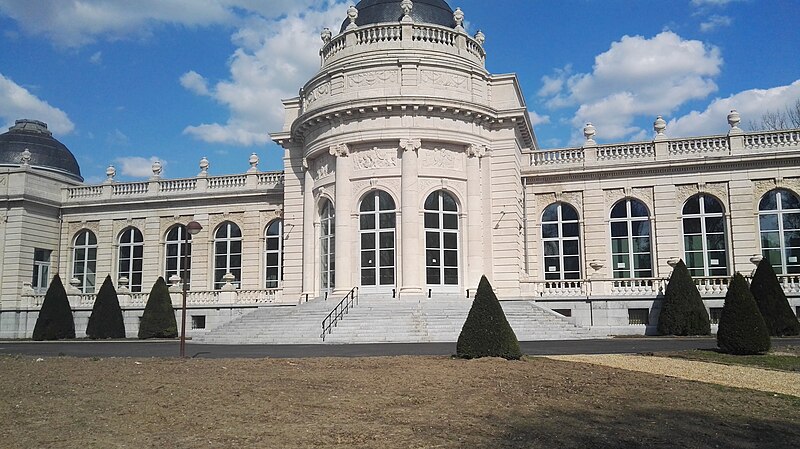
(400, 139, 425, 298)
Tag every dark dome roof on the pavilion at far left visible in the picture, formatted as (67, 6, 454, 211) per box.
(0, 120, 83, 181)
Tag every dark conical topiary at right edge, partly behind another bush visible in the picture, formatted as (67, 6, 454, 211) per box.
(750, 257, 800, 337)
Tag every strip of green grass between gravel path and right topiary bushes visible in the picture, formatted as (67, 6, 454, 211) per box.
(657, 346, 800, 372)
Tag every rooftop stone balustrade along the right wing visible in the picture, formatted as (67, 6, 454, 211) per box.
(530, 129, 800, 168)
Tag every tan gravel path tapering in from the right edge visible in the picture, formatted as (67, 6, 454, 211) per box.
(550, 355, 800, 397)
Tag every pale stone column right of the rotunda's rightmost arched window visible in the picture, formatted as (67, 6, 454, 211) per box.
(464, 145, 486, 292)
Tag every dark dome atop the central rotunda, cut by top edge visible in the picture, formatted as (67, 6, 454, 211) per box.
(340, 0, 456, 32)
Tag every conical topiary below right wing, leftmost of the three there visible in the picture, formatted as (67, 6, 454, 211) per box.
(657, 260, 711, 335)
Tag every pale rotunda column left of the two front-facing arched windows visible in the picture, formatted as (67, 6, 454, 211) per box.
(330, 143, 355, 300)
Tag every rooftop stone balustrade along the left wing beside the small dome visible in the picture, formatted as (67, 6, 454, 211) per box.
(62, 172, 284, 203)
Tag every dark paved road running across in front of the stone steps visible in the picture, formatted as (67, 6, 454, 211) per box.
(0, 337, 800, 358)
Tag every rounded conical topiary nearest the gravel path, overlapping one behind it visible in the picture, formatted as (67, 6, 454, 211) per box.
(717, 273, 770, 355)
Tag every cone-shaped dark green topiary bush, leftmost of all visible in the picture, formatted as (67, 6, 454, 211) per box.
(33, 274, 75, 340)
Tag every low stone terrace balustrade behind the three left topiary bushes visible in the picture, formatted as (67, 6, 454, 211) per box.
(22, 288, 282, 309)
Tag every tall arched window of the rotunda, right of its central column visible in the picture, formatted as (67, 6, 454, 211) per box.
(425, 190, 459, 286)
